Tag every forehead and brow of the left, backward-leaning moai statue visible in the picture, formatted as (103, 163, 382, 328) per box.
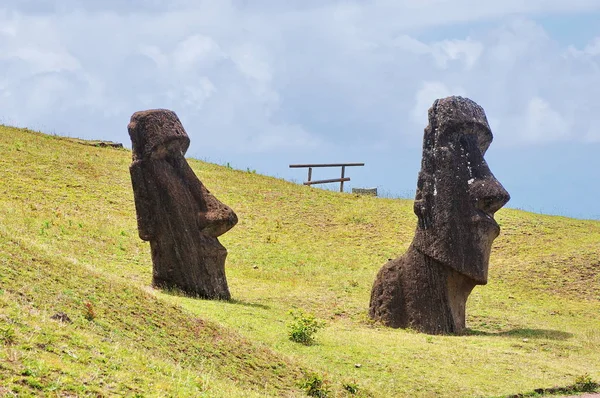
(127, 109, 190, 160)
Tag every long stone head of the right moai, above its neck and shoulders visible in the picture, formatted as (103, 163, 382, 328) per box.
(413, 97, 510, 284)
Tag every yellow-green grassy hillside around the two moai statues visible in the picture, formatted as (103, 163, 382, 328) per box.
(0, 127, 600, 397)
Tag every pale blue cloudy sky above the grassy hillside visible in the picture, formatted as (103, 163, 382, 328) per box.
(0, 0, 600, 219)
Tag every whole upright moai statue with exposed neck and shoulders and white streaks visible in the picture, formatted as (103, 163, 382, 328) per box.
(369, 97, 510, 334)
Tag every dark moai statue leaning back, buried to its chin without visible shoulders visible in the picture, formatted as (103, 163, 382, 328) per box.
(127, 109, 237, 300)
